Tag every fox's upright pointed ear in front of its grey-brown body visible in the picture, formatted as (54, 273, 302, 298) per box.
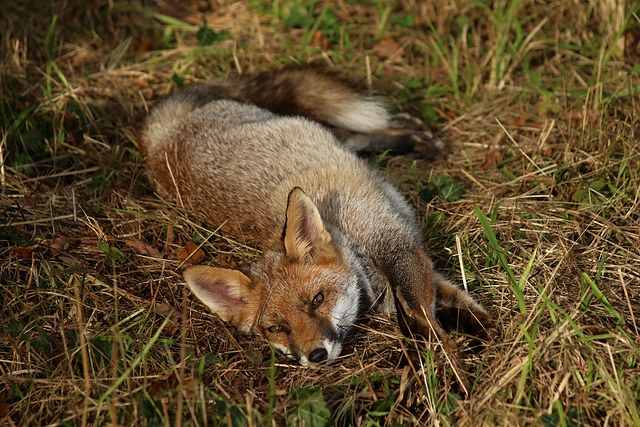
(284, 187, 334, 262)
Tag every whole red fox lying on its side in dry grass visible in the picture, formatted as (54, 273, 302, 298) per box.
(140, 68, 492, 374)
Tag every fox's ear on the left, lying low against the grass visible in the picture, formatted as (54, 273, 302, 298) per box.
(182, 265, 252, 329)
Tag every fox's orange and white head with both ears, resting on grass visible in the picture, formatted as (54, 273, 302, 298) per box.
(183, 187, 361, 366)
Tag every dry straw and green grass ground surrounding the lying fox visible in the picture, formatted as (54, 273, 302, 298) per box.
(0, 0, 640, 426)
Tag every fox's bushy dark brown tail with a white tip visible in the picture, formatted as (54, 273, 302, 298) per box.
(144, 68, 390, 133)
